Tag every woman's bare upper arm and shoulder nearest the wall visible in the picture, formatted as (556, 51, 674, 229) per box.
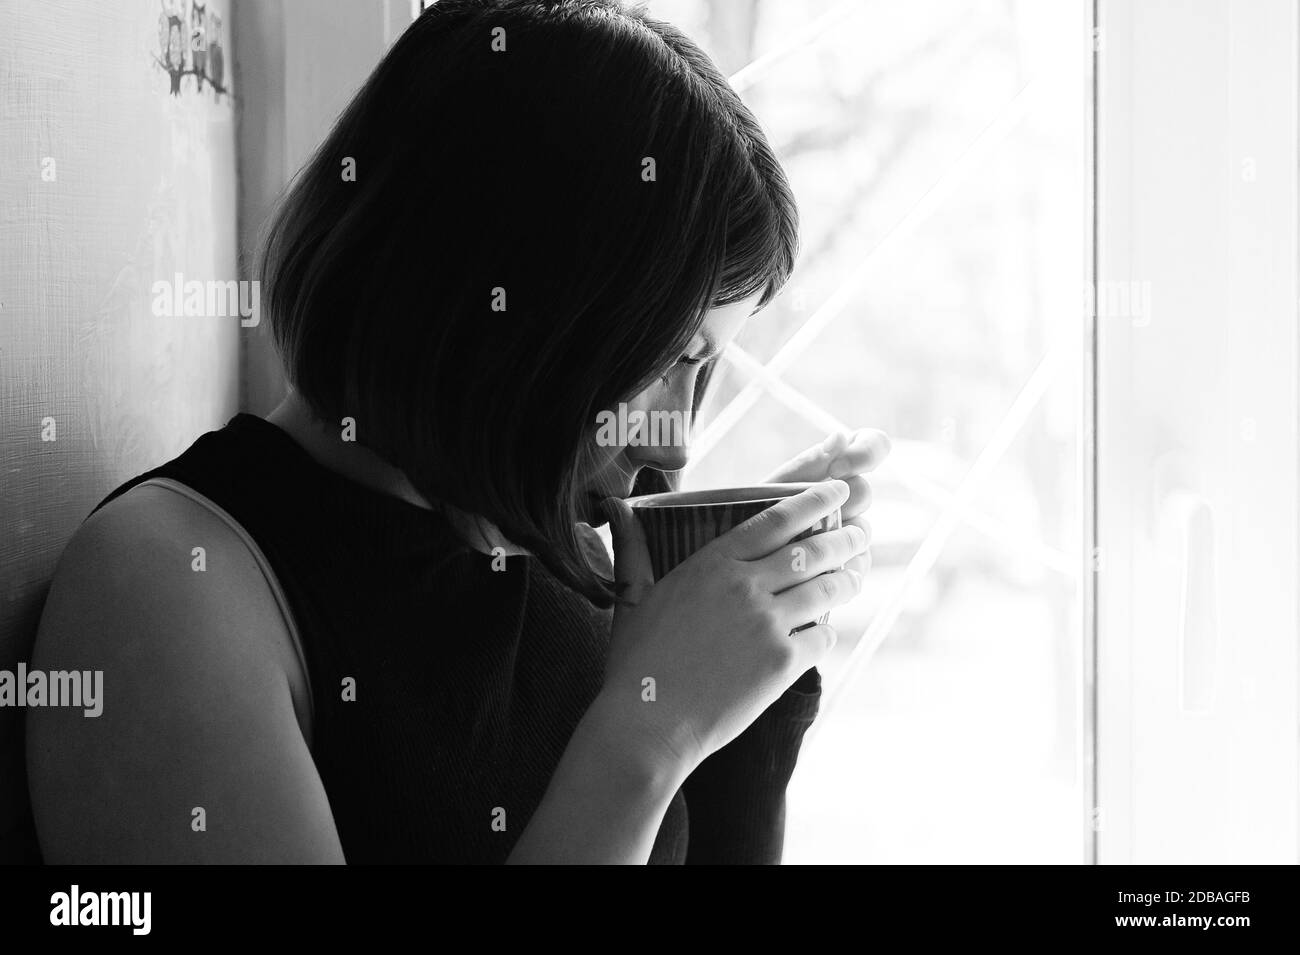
(27, 483, 342, 863)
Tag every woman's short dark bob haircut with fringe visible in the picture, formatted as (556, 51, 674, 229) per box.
(259, 0, 798, 607)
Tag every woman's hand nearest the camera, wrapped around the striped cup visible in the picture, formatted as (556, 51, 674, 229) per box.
(601, 481, 868, 773)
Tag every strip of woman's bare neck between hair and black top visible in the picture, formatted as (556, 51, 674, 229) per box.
(267, 390, 528, 555)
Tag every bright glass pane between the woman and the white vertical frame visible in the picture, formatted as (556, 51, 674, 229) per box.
(650, 0, 1091, 863)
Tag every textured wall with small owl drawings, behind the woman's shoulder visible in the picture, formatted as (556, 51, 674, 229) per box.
(0, 0, 241, 861)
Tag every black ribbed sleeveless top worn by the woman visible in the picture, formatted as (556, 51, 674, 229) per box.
(96, 414, 820, 864)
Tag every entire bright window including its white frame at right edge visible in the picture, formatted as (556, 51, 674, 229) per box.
(651, 0, 1300, 863)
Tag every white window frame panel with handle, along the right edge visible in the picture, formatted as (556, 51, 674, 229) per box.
(1095, 0, 1300, 864)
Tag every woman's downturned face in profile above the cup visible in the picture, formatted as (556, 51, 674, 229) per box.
(586, 292, 761, 524)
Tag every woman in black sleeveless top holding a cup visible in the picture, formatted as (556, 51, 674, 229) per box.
(27, 0, 888, 863)
